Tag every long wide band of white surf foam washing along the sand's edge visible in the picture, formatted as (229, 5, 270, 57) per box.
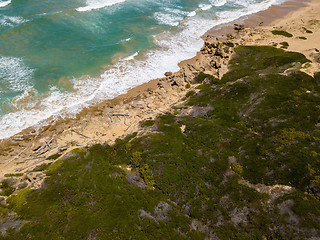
(0, 0, 288, 139)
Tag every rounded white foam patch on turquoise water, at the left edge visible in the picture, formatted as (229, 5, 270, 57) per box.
(0, 55, 33, 92)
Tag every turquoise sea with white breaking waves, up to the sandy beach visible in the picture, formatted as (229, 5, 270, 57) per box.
(0, 0, 284, 139)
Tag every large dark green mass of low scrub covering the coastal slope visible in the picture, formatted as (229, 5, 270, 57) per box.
(0, 46, 320, 239)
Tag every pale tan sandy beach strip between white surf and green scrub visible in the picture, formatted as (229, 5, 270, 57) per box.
(0, 0, 320, 185)
